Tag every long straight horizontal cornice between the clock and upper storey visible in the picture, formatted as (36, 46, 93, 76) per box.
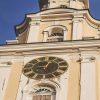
(0, 40, 100, 56)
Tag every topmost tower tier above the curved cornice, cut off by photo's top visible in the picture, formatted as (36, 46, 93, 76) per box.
(39, 0, 89, 10)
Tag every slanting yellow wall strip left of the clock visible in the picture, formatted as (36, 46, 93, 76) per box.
(3, 56, 23, 100)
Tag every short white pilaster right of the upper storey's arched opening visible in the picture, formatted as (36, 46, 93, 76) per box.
(72, 18, 83, 40)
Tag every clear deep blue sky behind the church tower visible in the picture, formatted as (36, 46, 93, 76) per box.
(0, 0, 100, 44)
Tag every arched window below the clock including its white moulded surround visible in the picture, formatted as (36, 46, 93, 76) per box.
(18, 77, 61, 100)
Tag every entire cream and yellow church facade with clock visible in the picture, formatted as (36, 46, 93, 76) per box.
(0, 0, 100, 100)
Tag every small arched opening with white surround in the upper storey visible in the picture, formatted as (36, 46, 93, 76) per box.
(43, 26, 67, 42)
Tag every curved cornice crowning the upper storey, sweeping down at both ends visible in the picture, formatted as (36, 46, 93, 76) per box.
(15, 8, 100, 36)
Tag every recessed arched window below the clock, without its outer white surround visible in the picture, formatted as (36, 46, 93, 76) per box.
(32, 83, 56, 100)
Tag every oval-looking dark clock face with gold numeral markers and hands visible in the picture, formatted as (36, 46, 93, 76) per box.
(23, 57, 68, 79)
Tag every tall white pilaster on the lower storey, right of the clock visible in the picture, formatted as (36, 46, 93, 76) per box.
(80, 58, 96, 100)
